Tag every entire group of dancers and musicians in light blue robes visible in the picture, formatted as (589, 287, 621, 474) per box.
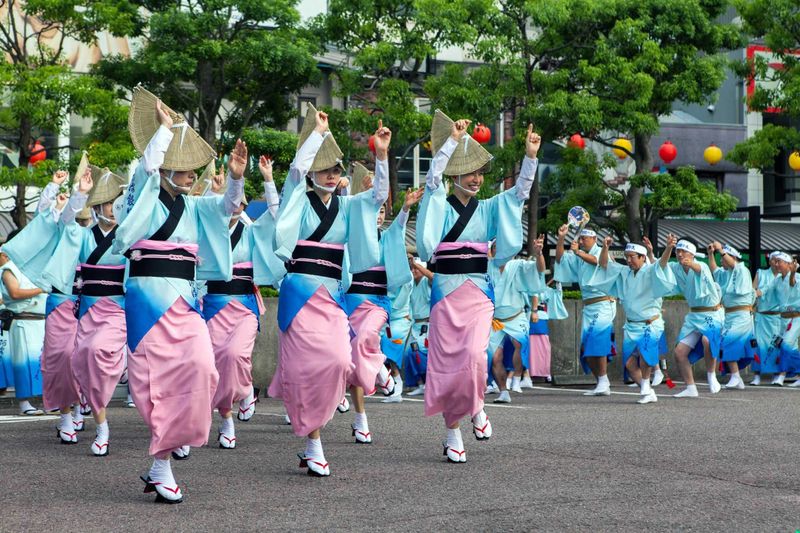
(0, 87, 800, 503)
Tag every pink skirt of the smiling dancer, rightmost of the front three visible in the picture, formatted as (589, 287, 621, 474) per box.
(425, 281, 494, 426)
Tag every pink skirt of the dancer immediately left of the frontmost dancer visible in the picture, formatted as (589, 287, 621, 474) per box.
(72, 298, 127, 411)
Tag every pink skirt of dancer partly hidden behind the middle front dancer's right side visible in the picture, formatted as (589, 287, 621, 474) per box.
(348, 302, 389, 393)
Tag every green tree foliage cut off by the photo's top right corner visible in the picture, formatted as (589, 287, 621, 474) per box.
(727, 0, 800, 172)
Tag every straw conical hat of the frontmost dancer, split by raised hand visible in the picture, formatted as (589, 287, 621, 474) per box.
(128, 86, 215, 171)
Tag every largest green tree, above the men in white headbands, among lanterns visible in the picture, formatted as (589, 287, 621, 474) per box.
(429, 0, 741, 240)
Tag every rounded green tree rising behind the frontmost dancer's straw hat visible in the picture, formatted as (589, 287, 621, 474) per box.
(96, 0, 319, 146)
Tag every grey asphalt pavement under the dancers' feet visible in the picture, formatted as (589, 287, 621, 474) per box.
(0, 386, 800, 532)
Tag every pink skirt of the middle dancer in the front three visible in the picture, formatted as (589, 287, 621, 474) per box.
(269, 286, 352, 436)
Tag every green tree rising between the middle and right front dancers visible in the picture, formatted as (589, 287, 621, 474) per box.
(313, 0, 491, 204)
